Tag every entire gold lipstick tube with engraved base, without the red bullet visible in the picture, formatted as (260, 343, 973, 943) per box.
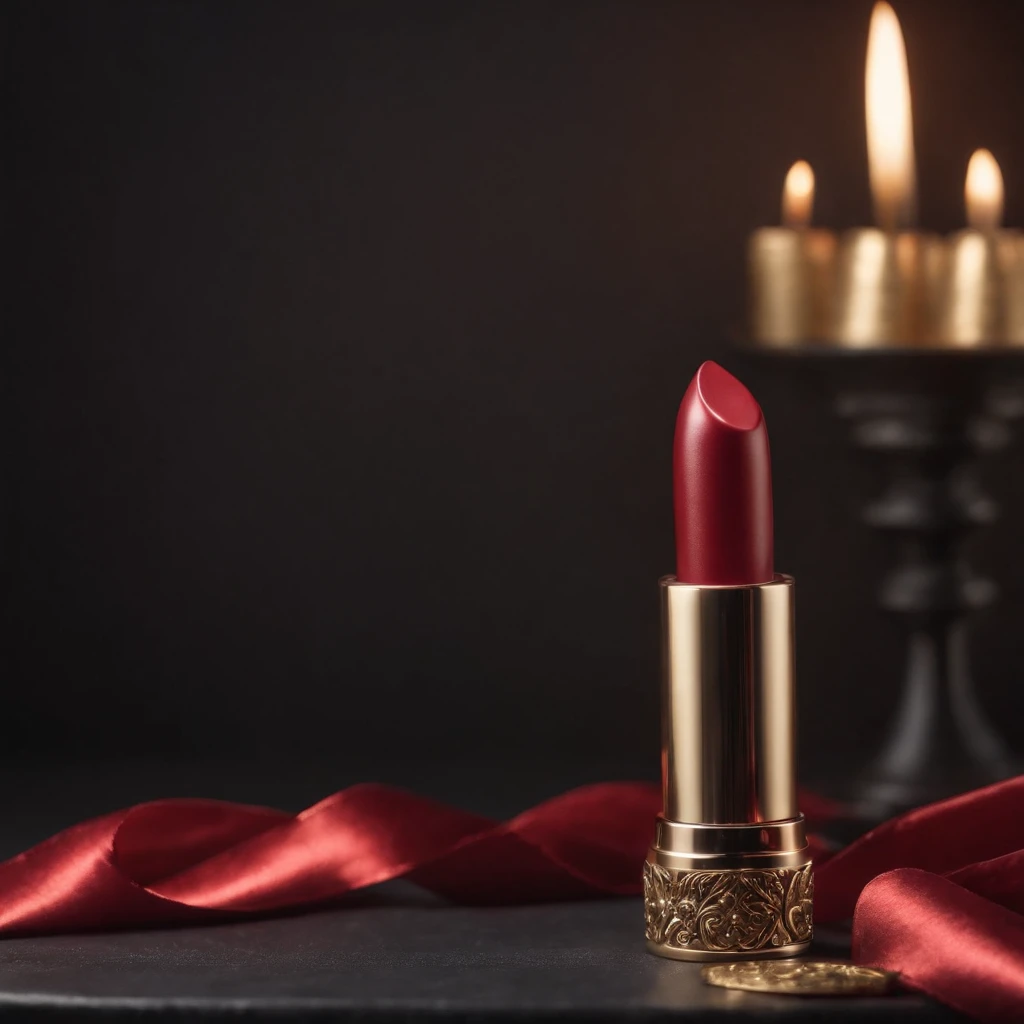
(644, 575, 813, 961)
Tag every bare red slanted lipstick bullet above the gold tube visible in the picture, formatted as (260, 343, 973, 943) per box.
(673, 362, 774, 587)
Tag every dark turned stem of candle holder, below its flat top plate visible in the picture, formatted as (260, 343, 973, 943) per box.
(839, 381, 1014, 819)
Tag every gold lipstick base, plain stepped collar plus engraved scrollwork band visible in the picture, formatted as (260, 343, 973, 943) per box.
(643, 819, 814, 962)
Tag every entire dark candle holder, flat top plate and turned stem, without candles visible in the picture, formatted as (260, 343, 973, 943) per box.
(749, 345, 1024, 824)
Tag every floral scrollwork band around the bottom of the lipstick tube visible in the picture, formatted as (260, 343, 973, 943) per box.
(643, 863, 814, 952)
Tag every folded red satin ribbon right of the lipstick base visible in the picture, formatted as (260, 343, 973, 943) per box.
(831, 776, 1024, 1022)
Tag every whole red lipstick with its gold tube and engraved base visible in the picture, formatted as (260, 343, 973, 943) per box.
(644, 362, 813, 961)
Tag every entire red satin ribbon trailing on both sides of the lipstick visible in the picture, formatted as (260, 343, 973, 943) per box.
(0, 776, 1024, 1021)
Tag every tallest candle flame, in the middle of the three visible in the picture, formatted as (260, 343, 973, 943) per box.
(864, 0, 916, 231)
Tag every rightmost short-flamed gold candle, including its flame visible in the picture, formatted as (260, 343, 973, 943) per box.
(939, 150, 1024, 346)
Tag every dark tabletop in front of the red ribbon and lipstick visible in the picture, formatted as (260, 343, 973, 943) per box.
(0, 899, 956, 1022)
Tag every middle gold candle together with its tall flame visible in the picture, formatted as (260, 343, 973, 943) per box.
(833, 2, 941, 347)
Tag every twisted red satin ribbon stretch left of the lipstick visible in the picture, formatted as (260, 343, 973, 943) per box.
(0, 782, 660, 934)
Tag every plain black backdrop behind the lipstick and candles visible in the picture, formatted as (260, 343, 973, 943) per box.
(2, 0, 1024, 796)
